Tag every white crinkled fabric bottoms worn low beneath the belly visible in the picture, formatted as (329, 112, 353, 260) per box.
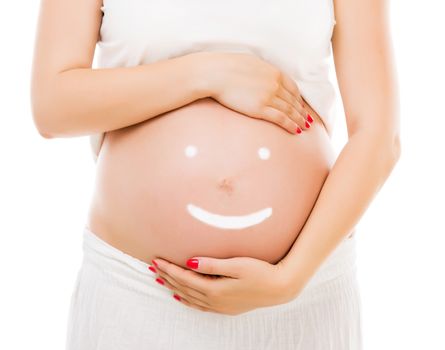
(66, 228, 362, 350)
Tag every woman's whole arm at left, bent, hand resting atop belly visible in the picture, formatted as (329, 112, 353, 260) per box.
(31, 0, 307, 138)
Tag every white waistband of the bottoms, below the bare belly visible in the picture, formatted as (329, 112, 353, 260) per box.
(82, 227, 356, 302)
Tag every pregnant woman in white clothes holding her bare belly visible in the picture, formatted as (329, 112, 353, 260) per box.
(32, 0, 400, 350)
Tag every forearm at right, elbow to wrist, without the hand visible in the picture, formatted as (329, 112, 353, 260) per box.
(282, 131, 400, 292)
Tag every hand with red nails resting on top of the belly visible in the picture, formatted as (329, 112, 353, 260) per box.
(194, 51, 313, 134)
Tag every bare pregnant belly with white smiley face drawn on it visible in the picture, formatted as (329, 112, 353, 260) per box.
(87, 98, 334, 267)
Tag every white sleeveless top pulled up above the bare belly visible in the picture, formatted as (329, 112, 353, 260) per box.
(90, 0, 336, 160)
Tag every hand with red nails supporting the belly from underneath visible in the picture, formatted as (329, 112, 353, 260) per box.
(151, 257, 300, 315)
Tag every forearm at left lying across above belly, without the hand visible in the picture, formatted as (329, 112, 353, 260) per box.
(33, 54, 206, 137)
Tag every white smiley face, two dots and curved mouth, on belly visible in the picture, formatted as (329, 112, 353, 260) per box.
(184, 145, 272, 229)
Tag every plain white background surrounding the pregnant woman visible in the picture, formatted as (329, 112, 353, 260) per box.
(0, 0, 445, 350)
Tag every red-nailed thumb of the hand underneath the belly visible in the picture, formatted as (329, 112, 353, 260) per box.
(186, 257, 243, 277)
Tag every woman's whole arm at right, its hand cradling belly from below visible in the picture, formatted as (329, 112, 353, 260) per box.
(149, 0, 401, 315)
